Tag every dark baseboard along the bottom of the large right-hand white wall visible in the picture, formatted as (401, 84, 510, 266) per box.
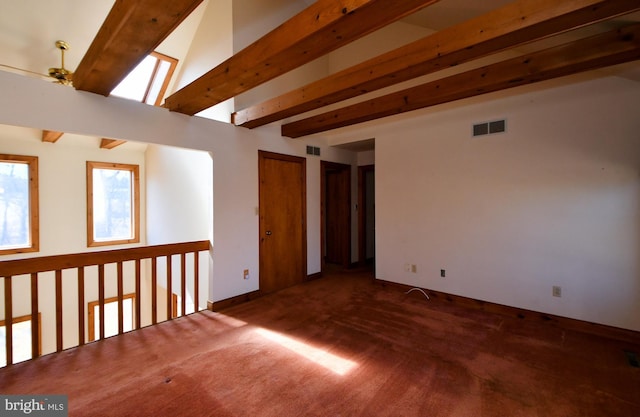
(375, 278, 640, 344)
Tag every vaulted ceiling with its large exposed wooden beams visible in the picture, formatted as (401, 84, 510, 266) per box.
(0, 0, 640, 141)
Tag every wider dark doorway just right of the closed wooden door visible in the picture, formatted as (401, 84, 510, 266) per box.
(320, 161, 351, 270)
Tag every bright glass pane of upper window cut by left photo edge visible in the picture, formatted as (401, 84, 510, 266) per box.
(0, 162, 31, 249)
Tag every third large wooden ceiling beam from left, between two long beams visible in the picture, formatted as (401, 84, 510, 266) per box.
(232, 0, 640, 128)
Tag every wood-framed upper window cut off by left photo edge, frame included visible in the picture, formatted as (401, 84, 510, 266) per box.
(0, 154, 39, 255)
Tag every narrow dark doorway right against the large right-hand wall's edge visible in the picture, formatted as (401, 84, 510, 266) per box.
(358, 165, 376, 265)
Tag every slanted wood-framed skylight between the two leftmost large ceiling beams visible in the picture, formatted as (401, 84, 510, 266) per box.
(111, 52, 178, 106)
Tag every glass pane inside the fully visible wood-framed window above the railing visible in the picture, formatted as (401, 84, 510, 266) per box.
(93, 168, 134, 241)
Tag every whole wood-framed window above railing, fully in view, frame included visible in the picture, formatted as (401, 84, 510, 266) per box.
(87, 161, 140, 246)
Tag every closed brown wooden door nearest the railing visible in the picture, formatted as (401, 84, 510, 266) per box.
(258, 151, 307, 293)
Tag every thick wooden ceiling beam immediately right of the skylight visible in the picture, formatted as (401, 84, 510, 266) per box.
(164, 0, 438, 115)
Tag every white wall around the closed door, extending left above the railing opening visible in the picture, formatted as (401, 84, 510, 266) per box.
(0, 73, 357, 301)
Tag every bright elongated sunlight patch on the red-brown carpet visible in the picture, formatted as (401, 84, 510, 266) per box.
(255, 327, 357, 375)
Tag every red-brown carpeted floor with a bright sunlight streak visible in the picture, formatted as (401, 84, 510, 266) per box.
(0, 272, 640, 417)
